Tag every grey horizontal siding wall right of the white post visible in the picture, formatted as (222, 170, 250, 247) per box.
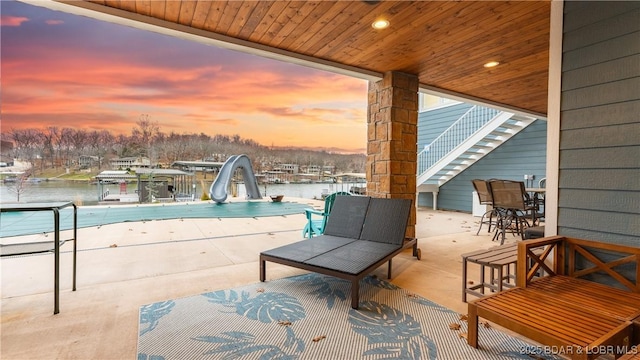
(558, 1, 640, 246)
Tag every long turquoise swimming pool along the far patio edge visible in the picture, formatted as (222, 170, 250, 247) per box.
(0, 201, 310, 238)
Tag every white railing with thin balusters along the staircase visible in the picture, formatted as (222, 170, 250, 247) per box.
(418, 105, 500, 175)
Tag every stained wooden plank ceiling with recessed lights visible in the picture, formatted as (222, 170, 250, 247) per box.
(70, 0, 550, 114)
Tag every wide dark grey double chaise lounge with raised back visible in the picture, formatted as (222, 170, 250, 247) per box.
(260, 196, 419, 309)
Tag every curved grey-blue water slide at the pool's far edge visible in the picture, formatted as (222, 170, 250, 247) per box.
(209, 155, 262, 203)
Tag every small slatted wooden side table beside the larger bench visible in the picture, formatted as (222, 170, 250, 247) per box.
(462, 243, 518, 302)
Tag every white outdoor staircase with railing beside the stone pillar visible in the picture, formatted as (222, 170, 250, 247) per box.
(417, 106, 535, 188)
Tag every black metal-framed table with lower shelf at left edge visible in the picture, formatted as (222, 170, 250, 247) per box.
(0, 201, 78, 314)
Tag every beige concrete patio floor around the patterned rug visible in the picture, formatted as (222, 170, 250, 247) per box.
(0, 199, 517, 359)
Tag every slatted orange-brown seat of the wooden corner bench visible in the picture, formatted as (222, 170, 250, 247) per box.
(473, 275, 640, 346)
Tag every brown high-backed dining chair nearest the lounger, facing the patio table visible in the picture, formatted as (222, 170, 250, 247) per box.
(488, 180, 535, 244)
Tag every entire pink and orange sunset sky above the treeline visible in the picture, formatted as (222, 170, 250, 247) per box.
(0, 1, 367, 153)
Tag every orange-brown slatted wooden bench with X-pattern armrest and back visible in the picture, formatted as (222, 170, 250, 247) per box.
(468, 236, 640, 359)
